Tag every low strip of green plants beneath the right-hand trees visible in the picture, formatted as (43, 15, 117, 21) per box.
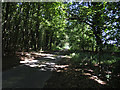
(71, 52, 120, 65)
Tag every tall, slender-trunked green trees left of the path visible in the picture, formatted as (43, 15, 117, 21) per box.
(2, 2, 66, 54)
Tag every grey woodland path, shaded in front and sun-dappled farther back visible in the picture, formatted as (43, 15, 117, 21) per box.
(2, 52, 70, 88)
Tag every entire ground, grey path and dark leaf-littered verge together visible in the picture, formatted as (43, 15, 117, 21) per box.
(3, 52, 120, 88)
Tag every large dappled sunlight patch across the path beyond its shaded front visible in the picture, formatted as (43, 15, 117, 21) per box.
(20, 52, 71, 71)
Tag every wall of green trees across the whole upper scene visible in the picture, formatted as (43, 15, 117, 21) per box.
(2, 2, 120, 55)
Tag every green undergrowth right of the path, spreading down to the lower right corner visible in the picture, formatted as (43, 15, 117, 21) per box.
(71, 52, 120, 88)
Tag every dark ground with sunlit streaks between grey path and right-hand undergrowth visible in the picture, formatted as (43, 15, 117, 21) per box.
(44, 59, 107, 88)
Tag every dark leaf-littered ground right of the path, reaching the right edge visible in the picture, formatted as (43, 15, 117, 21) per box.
(44, 51, 120, 88)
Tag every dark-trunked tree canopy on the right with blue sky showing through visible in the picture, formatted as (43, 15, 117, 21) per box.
(67, 2, 119, 51)
